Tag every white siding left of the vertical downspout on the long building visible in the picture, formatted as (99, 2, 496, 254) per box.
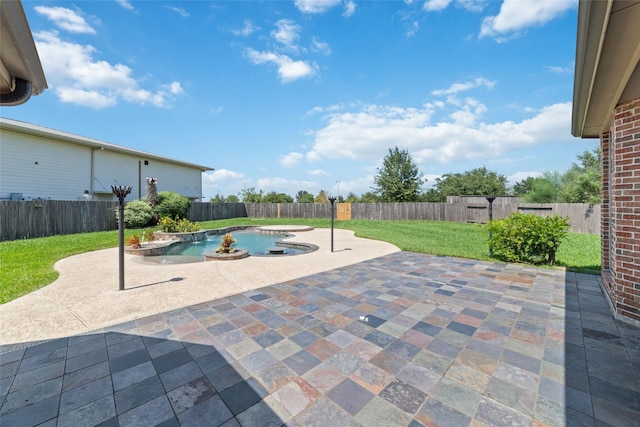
(0, 130, 91, 200)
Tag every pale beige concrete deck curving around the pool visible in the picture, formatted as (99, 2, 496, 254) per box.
(0, 226, 399, 345)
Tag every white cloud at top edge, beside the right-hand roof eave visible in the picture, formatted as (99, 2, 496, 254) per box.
(480, 0, 577, 41)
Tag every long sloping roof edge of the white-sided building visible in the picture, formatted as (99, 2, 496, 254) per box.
(0, 117, 214, 172)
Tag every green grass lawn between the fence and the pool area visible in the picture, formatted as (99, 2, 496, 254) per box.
(0, 218, 600, 304)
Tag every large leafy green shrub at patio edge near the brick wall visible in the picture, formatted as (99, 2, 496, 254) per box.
(487, 212, 569, 265)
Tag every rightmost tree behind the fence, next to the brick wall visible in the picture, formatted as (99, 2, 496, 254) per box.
(558, 148, 600, 203)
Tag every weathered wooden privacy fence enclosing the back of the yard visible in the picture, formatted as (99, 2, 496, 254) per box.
(0, 198, 600, 241)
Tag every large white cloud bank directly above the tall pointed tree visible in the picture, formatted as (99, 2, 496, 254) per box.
(306, 99, 573, 164)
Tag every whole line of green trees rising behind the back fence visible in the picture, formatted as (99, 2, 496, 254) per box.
(211, 147, 600, 203)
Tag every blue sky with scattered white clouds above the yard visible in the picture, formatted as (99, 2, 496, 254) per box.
(1, 0, 598, 200)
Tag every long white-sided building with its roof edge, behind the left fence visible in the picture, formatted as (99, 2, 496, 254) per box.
(0, 117, 212, 201)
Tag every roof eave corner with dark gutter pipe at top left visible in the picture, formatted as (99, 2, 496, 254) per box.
(0, 0, 47, 106)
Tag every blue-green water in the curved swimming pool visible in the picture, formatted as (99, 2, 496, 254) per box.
(166, 231, 308, 257)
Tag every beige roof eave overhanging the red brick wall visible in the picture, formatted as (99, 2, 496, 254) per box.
(571, 0, 640, 138)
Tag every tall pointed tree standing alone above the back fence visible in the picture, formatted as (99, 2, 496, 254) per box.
(373, 147, 424, 202)
